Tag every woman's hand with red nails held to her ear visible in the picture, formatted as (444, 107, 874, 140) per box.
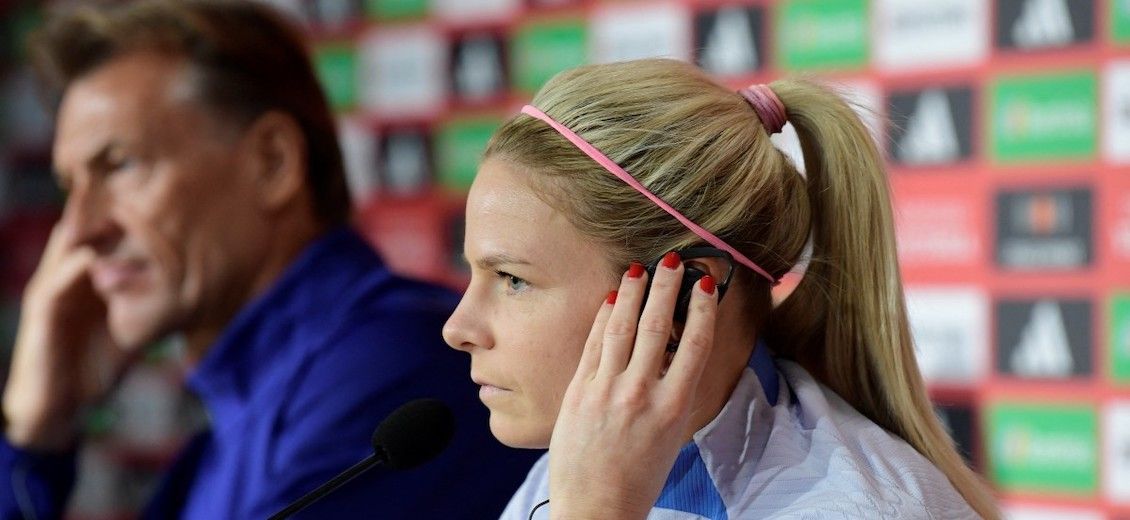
(549, 252, 718, 519)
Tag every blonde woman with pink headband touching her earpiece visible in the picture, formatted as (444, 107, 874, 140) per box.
(444, 60, 998, 519)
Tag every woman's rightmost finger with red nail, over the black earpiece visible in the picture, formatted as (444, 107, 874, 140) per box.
(663, 276, 718, 395)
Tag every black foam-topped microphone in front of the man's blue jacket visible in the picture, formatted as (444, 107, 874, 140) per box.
(269, 399, 455, 520)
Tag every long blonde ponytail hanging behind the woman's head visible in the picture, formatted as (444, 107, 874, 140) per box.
(765, 80, 999, 518)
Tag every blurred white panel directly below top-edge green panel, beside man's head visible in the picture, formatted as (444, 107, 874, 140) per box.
(358, 27, 447, 116)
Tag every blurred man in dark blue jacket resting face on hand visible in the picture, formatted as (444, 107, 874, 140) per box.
(0, 0, 537, 519)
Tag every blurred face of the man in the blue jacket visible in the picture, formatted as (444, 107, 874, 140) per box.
(54, 53, 272, 349)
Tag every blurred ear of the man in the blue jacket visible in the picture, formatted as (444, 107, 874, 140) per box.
(244, 111, 307, 213)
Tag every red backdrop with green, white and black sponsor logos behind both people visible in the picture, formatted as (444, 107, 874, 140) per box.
(0, 0, 1130, 519)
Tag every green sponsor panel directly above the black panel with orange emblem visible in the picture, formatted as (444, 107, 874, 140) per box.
(990, 71, 1098, 163)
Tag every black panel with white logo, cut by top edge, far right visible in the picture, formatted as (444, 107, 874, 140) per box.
(997, 0, 1095, 50)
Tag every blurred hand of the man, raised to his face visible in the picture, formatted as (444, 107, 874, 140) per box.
(3, 220, 130, 451)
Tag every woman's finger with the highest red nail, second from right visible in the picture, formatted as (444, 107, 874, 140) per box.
(628, 251, 684, 379)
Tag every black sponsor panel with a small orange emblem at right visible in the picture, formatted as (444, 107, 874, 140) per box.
(997, 189, 1094, 270)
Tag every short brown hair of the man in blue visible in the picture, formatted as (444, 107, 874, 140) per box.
(29, 0, 351, 225)
